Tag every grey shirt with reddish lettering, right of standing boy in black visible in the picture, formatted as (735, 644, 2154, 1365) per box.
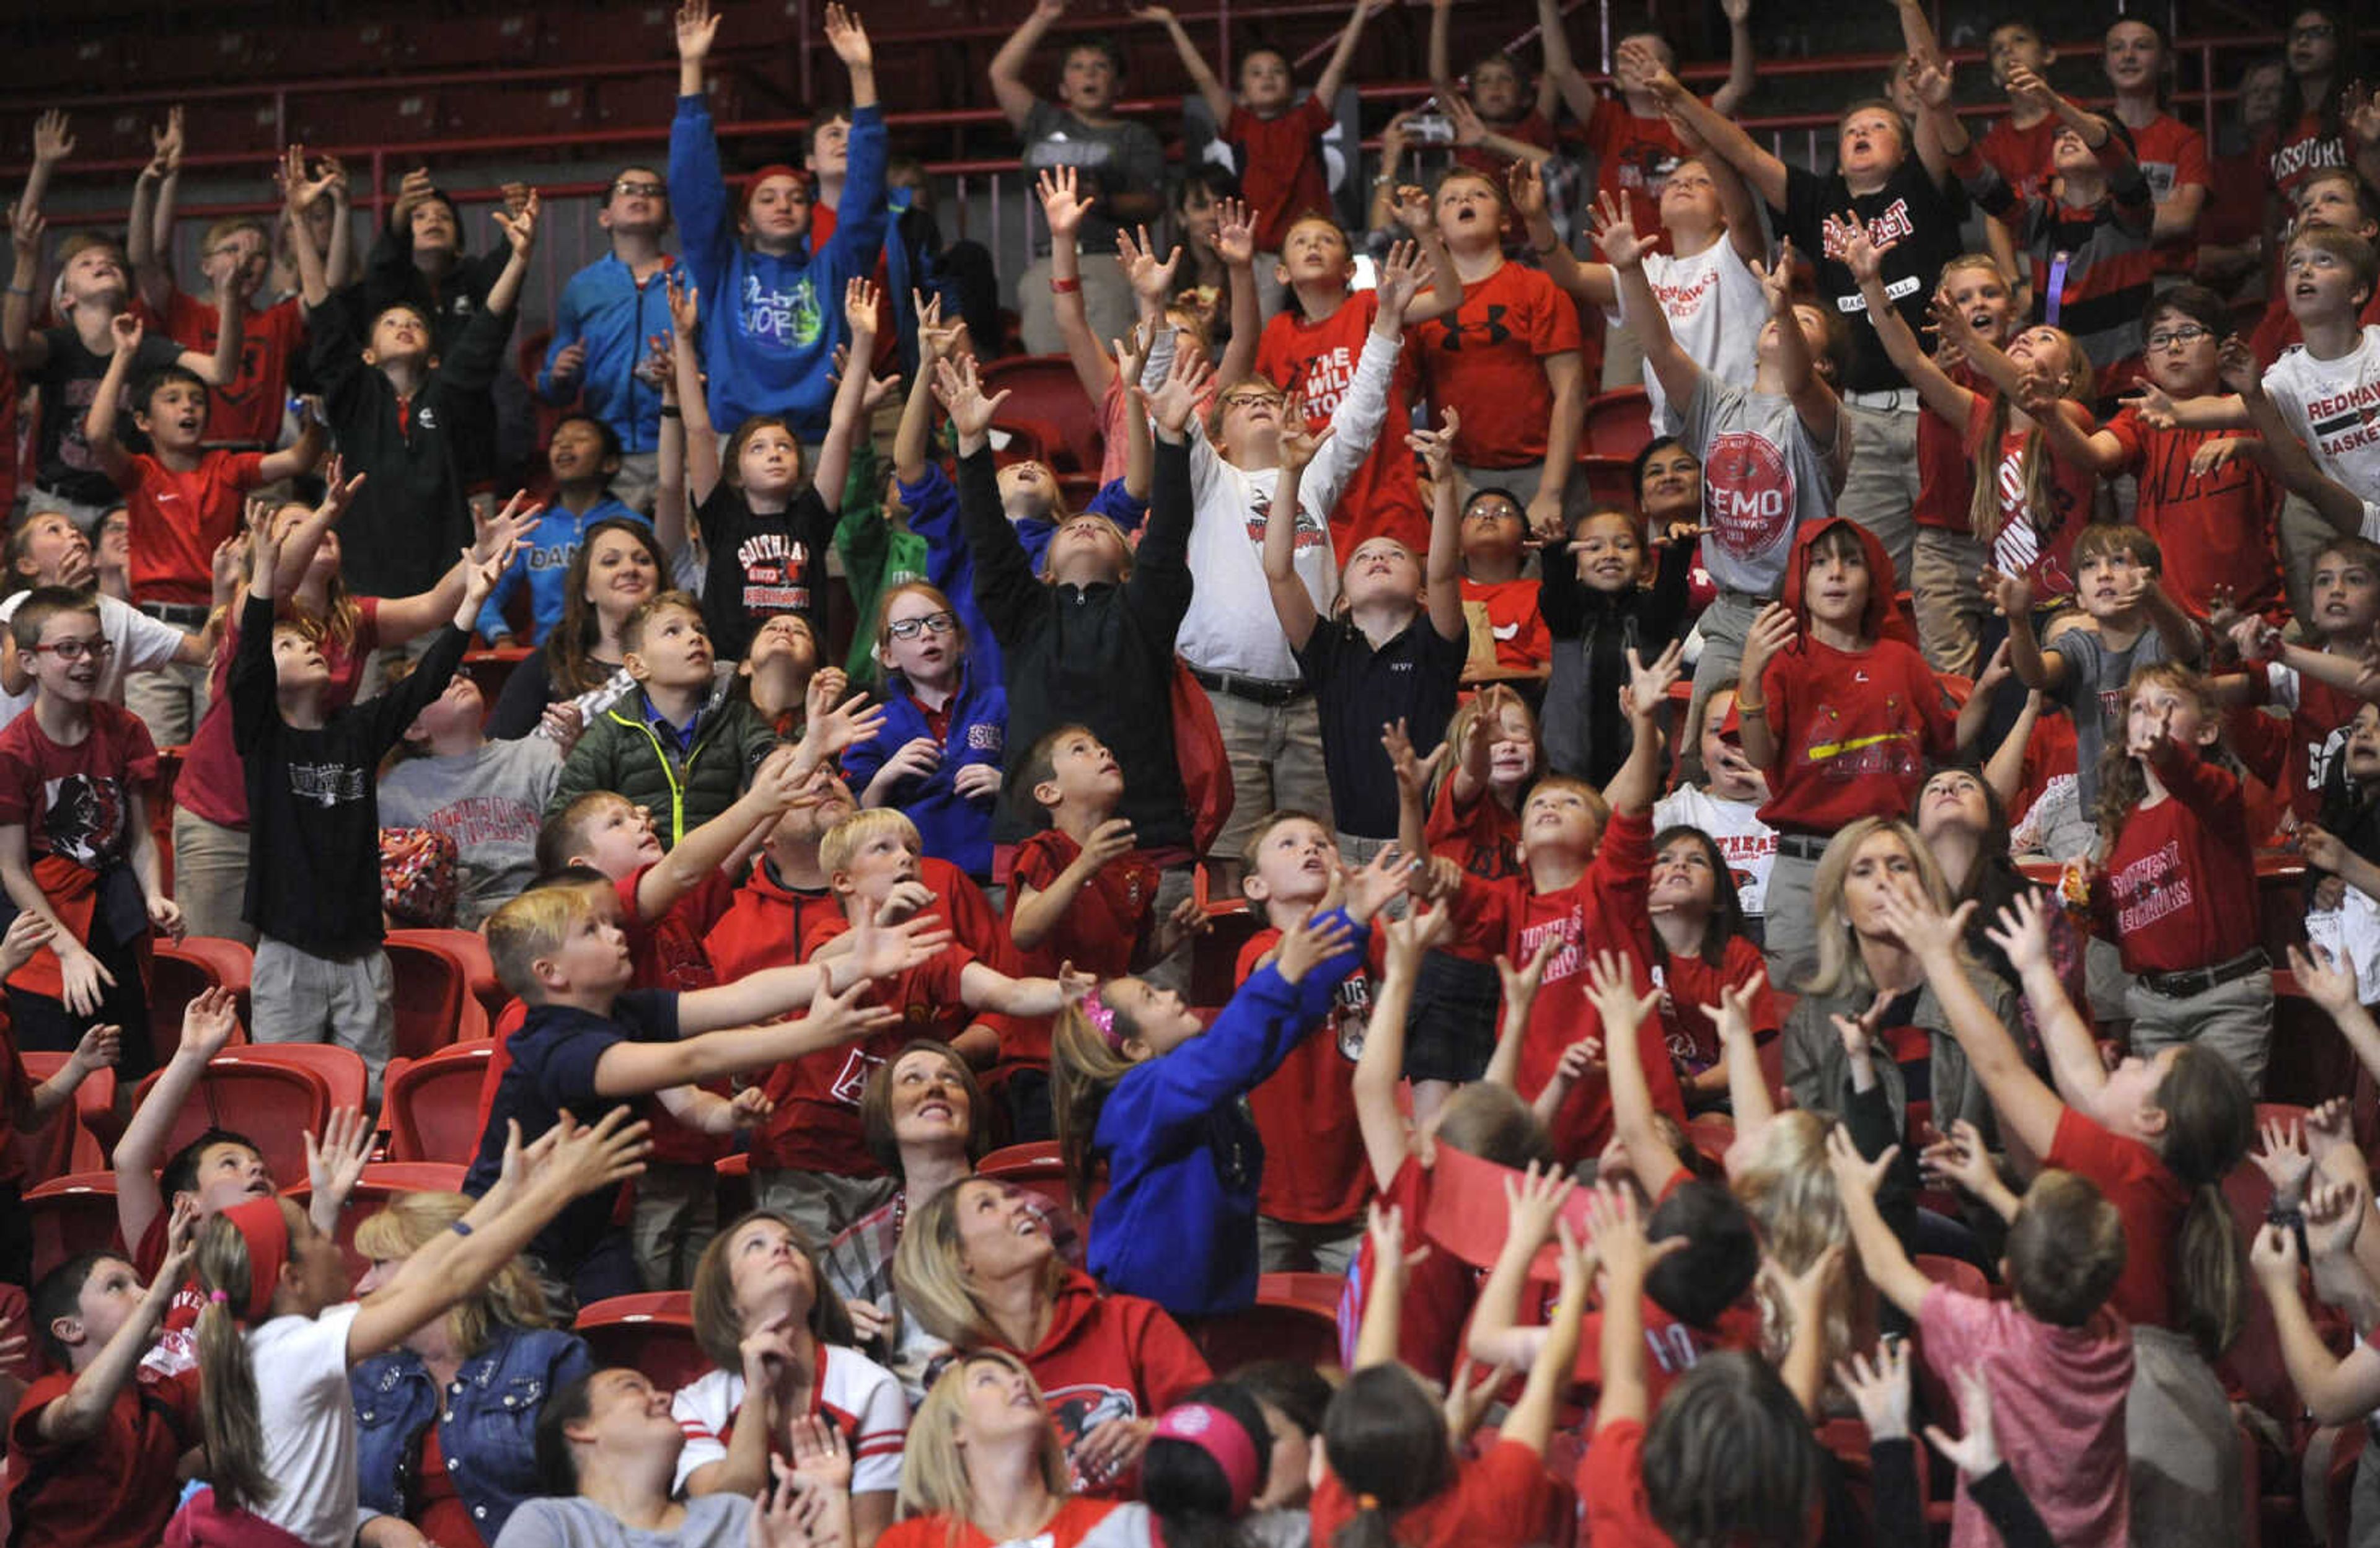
(381, 735, 562, 930)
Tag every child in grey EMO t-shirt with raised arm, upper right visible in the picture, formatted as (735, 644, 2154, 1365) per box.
(1595, 200, 1852, 723)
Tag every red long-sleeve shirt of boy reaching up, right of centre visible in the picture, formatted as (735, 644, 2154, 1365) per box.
(1454, 813, 1695, 1161)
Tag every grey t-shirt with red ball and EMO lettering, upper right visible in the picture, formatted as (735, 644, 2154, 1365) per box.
(1678, 371, 1844, 597)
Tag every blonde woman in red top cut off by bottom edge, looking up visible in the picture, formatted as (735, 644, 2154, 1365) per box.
(878, 1348, 1157, 1548)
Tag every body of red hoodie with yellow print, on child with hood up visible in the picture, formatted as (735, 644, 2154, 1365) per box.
(1759, 635, 1959, 832)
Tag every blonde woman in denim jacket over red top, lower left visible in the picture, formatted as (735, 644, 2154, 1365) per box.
(348, 1194, 595, 1548)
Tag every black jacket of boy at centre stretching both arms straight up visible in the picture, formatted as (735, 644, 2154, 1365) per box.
(959, 438, 1190, 849)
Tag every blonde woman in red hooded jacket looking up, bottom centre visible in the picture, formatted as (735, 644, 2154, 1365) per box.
(892, 1177, 1214, 1498)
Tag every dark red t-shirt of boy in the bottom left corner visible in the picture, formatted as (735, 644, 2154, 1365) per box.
(7, 1370, 205, 1548)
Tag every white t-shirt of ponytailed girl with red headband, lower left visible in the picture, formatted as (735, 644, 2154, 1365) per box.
(247, 1301, 359, 1548)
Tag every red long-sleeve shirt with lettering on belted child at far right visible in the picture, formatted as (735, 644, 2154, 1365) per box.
(2106, 747, 2256, 972)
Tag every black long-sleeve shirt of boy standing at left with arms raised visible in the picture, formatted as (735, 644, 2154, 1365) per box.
(231, 594, 469, 956)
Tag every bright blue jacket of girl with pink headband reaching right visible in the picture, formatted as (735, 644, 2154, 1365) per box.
(1088, 908, 1368, 1317)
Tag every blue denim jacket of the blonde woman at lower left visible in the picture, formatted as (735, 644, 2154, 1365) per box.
(348, 1324, 595, 1543)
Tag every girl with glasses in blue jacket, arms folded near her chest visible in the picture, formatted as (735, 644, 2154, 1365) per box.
(842, 580, 1009, 884)
